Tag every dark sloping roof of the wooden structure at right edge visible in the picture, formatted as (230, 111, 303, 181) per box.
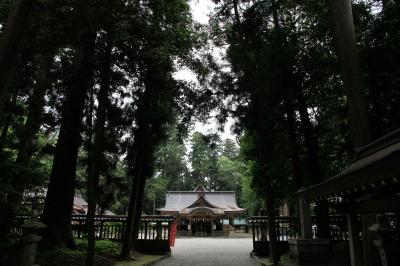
(297, 129, 400, 201)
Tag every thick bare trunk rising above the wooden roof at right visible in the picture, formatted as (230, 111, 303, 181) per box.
(329, 0, 371, 148)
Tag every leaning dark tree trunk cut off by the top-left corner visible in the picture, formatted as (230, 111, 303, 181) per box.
(0, 0, 33, 117)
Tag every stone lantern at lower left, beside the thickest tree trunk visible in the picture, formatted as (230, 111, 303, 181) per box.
(21, 212, 46, 266)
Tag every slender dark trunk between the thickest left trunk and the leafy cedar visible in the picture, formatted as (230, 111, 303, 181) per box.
(86, 41, 112, 266)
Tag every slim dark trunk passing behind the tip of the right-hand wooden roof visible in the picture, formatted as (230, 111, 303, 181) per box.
(297, 91, 330, 239)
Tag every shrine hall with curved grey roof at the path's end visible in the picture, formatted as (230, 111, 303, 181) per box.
(159, 186, 244, 236)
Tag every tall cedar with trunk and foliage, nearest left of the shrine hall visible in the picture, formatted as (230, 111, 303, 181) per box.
(122, 0, 197, 257)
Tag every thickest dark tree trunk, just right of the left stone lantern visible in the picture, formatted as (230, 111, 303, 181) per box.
(42, 25, 96, 247)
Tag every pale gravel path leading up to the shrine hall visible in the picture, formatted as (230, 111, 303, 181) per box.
(156, 238, 258, 266)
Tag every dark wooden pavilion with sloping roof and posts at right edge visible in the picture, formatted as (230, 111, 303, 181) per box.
(297, 129, 400, 266)
